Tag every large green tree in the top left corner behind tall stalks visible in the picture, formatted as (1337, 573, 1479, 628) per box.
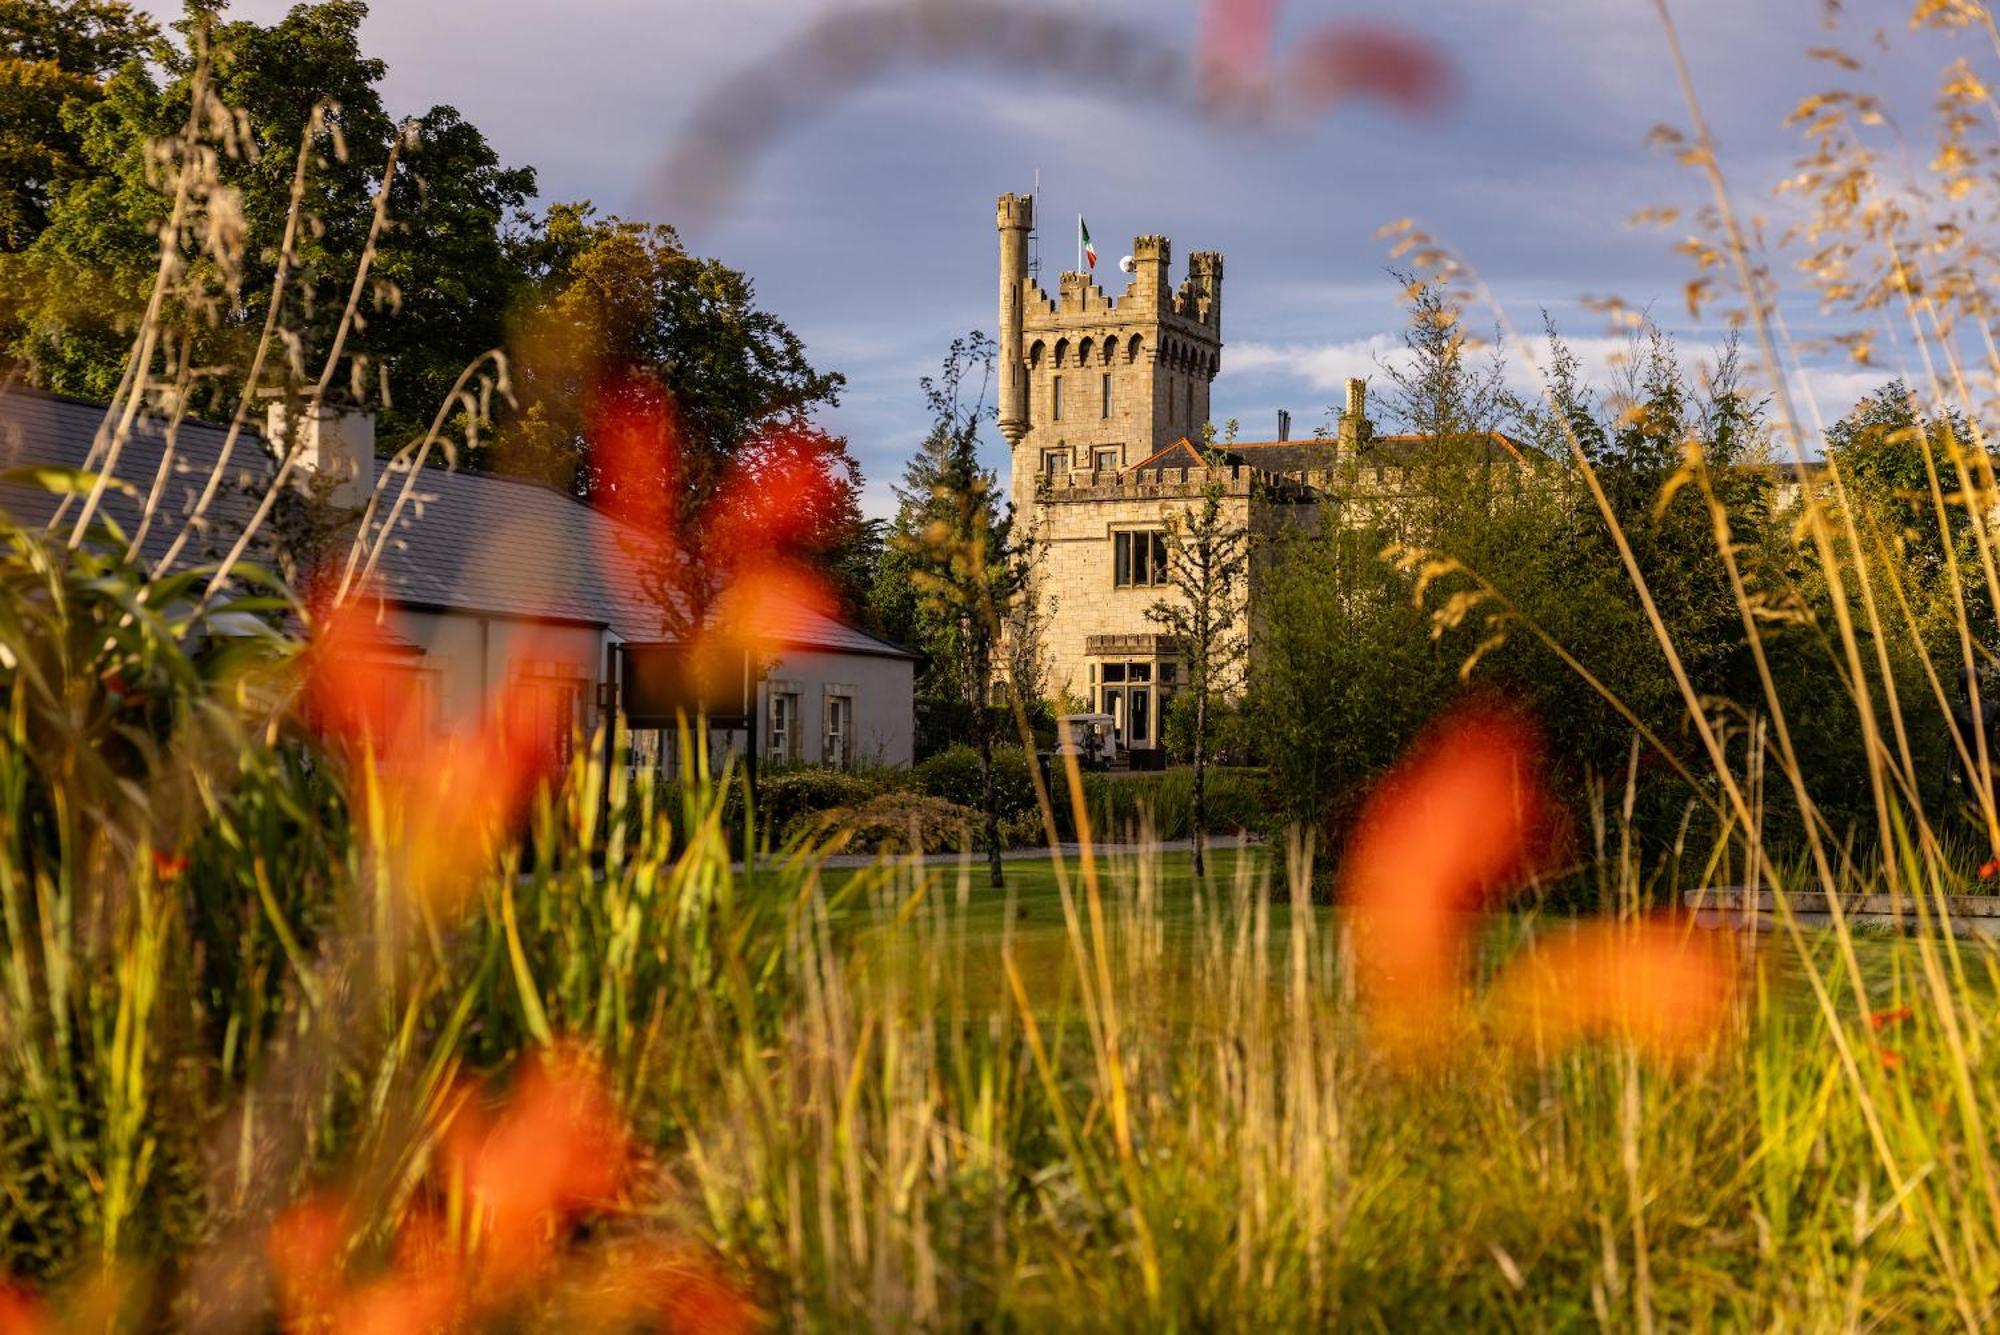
(8, 0, 534, 444)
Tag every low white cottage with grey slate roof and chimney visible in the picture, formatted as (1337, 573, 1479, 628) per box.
(0, 388, 918, 767)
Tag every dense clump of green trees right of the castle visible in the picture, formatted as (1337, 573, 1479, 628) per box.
(1246, 279, 1968, 855)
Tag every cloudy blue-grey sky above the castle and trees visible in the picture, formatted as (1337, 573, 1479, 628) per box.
(152, 0, 1950, 514)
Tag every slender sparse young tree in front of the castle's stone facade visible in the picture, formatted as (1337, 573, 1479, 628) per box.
(1146, 422, 1250, 877)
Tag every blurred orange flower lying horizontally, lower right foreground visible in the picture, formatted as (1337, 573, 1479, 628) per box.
(1490, 919, 1734, 1059)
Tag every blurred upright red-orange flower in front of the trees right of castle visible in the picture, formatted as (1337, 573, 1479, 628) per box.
(1340, 711, 1548, 1057)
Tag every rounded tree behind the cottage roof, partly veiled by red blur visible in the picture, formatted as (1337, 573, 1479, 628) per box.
(492, 204, 860, 636)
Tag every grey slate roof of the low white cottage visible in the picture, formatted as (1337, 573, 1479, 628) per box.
(0, 388, 918, 660)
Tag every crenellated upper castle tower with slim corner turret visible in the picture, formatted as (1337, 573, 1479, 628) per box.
(996, 194, 1222, 522)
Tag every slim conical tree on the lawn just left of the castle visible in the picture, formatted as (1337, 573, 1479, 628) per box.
(890, 334, 1026, 889)
